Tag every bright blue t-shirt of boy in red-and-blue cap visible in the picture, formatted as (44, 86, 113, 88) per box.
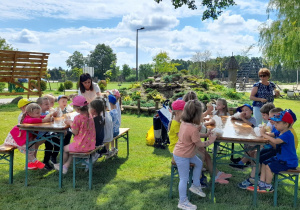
(276, 130, 298, 168)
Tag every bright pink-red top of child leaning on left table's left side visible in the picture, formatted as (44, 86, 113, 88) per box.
(10, 115, 46, 146)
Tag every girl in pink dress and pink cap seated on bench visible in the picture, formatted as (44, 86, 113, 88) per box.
(54, 96, 96, 174)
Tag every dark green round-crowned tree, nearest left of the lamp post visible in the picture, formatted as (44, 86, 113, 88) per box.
(89, 44, 117, 79)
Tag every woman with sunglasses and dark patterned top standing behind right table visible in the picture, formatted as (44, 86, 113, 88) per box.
(250, 68, 276, 125)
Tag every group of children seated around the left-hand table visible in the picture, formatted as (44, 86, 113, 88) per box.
(4, 90, 121, 174)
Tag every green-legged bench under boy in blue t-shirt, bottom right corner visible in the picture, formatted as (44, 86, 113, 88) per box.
(274, 167, 300, 208)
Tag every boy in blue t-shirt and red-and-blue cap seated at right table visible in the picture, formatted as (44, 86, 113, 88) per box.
(247, 110, 298, 193)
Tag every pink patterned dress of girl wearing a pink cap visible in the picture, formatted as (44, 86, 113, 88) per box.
(69, 114, 96, 152)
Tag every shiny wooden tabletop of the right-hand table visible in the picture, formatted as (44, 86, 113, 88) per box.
(207, 116, 268, 144)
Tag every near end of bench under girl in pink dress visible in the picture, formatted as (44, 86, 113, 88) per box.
(70, 145, 104, 190)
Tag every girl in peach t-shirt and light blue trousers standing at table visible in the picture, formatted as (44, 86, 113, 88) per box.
(173, 100, 216, 209)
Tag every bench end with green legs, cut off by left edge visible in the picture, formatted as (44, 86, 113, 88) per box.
(0, 145, 17, 184)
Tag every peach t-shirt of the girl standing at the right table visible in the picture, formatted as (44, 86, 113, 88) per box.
(173, 122, 201, 158)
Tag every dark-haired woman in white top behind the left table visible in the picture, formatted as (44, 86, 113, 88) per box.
(78, 73, 101, 103)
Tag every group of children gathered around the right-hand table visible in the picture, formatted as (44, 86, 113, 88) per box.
(169, 92, 298, 209)
